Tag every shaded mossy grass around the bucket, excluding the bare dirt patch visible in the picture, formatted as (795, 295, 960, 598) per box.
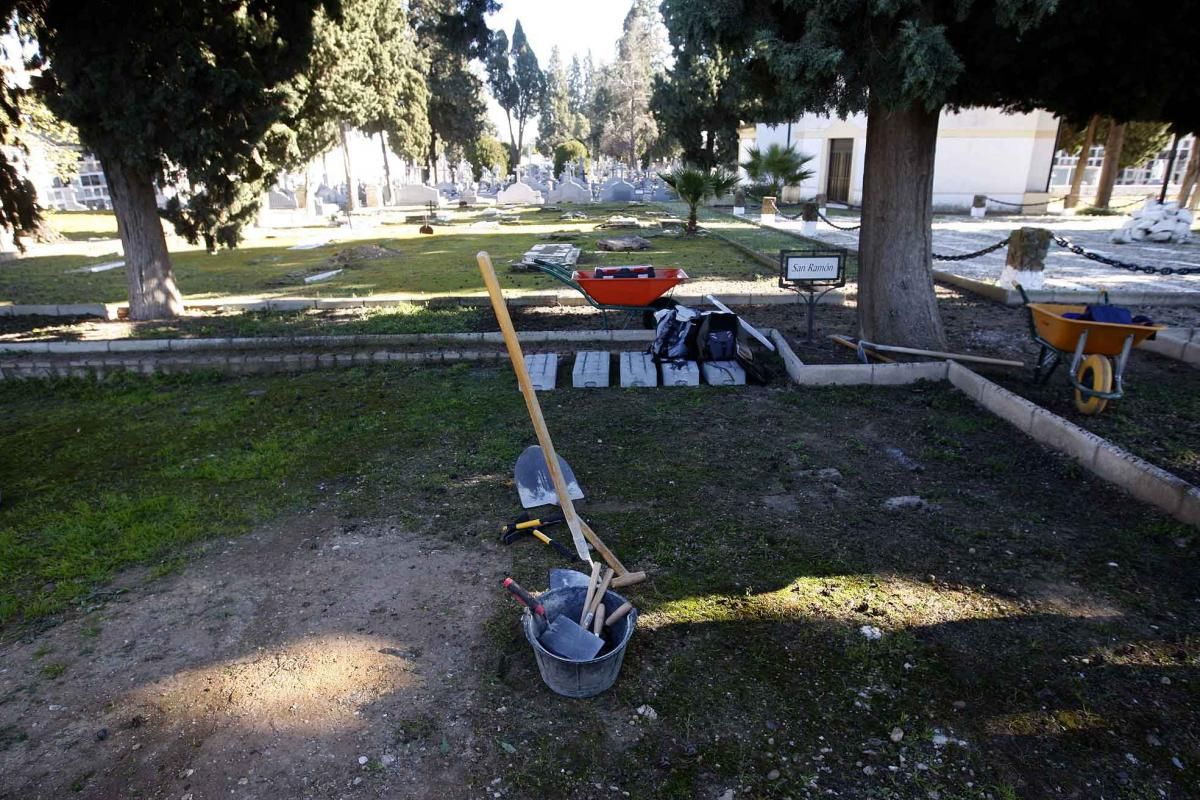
(0, 365, 1200, 800)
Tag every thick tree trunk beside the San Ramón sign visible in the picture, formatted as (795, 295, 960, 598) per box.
(858, 100, 946, 350)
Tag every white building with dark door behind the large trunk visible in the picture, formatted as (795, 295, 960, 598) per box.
(739, 108, 1058, 211)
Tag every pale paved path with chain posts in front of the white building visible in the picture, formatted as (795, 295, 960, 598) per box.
(750, 216, 1200, 298)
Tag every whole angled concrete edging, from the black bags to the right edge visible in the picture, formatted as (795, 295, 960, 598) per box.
(770, 330, 1200, 528)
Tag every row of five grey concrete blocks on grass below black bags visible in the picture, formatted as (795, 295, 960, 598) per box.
(524, 350, 746, 391)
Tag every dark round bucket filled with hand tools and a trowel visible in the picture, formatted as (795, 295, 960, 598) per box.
(521, 587, 637, 697)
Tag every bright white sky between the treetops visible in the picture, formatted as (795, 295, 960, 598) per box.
(487, 0, 632, 151)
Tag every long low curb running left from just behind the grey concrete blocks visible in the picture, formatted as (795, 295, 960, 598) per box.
(0, 330, 654, 355)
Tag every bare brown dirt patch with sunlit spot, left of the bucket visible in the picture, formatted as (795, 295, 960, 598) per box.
(0, 515, 506, 800)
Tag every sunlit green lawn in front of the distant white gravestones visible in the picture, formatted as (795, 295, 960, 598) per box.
(0, 205, 777, 303)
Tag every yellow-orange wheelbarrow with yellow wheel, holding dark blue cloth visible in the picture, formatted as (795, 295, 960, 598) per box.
(1016, 285, 1164, 414)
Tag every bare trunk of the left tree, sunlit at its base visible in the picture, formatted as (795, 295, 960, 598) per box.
(103, 158, 184, 319)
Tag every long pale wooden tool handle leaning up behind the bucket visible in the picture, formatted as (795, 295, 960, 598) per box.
(475, 251, 646, 585)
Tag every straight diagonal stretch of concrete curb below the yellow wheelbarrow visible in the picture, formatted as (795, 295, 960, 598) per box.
(947, 362, 1200, 527)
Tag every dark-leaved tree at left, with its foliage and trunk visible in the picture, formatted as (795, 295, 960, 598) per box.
(31, 0, 328, 319)
